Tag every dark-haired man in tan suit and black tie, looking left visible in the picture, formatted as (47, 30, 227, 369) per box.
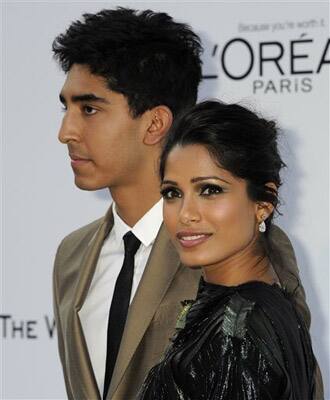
(53, 8, 324, 400)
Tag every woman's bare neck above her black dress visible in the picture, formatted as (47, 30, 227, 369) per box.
(203, 236, 278, 286)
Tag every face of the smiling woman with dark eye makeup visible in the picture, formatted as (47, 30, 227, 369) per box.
(161, 145, 258, 267)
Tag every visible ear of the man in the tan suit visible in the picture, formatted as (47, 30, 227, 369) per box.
(143, 105, 173, 146)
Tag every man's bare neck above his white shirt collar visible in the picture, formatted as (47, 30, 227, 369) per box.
(110, 184, 161, 227)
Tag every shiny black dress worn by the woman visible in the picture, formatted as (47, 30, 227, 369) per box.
(138, 280, 315, 400)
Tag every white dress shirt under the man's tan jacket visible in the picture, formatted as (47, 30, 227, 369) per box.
(79, 199, 163, 397)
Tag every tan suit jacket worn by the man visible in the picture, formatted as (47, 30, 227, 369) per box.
(53, 208, 322, 400)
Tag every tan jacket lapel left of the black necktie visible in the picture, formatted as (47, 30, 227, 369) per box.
(70, 207, 113, 399)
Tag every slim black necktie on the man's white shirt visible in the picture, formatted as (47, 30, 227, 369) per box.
(103, 231, 141, 399)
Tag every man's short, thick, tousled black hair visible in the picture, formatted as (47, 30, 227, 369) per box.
(52, 7, 202, 117)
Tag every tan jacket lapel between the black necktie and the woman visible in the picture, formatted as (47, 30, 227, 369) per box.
(107, 225, 180, 399)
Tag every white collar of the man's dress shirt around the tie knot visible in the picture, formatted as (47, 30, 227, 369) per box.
(112, 199, 163, 247)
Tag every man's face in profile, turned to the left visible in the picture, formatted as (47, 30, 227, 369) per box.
(58, 64, 146, 190)
